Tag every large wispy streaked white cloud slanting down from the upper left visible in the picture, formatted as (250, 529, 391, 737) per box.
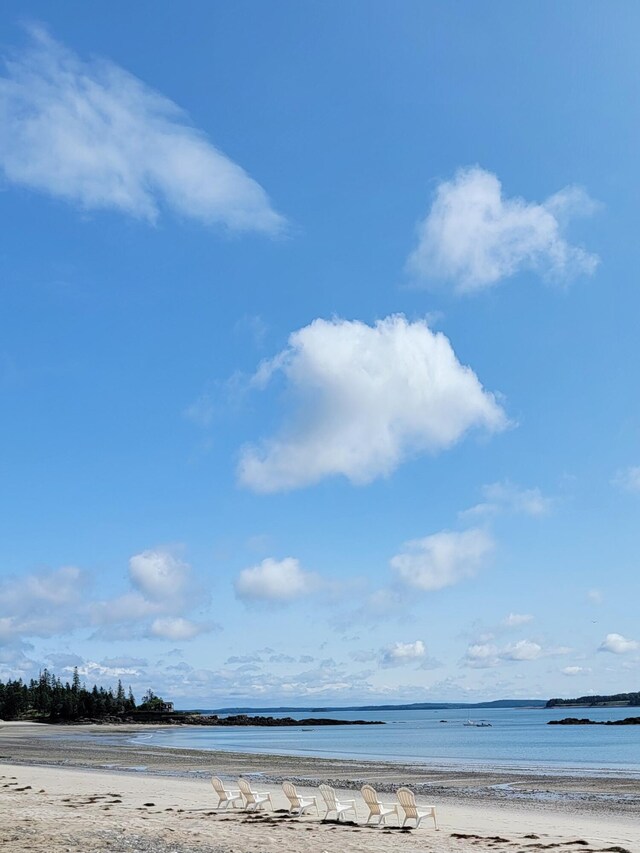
(0, 27, 284, 233)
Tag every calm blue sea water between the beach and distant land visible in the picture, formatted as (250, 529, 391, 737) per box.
(126, 708, 640, 778)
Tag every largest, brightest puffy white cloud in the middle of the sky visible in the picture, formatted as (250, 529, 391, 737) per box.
(239, 315, 508, 492)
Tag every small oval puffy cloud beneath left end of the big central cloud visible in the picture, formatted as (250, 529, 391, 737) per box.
(234, 557, 319, 602)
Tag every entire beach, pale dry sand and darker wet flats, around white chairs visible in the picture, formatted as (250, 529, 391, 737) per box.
(0, 724, 640, 853)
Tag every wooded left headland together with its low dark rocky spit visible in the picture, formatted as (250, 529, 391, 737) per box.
(0, 668, 384, 726)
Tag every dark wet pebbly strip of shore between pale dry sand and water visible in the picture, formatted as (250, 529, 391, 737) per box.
(0, 723, 640, 816)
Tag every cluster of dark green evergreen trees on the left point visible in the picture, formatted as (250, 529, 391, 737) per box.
(0, 667, 162, 723)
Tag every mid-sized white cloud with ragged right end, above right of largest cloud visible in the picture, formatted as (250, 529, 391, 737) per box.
(407, 166, 598, 293)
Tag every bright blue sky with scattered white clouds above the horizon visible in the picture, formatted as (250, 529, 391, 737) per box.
(0, 0, 640, 707)
